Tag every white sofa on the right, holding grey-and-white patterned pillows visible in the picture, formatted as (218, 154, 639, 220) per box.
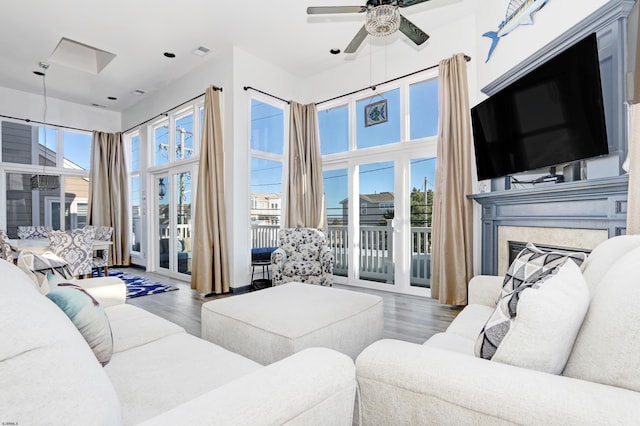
(356, 235, 640, 425)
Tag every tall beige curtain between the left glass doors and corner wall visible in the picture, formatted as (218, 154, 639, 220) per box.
(191, 86, 229, 294)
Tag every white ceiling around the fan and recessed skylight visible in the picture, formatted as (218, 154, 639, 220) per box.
(0, 0, 475, 111)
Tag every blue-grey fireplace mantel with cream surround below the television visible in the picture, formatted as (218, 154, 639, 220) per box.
(469, 175, 628, 275)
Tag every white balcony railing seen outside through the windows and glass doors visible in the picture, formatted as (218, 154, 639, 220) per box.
(251, 224, 431, 287)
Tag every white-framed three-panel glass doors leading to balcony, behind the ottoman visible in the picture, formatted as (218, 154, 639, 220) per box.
(324, 151, 436, 296)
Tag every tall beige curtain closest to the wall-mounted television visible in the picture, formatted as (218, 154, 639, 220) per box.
(431, 54, 474, 305)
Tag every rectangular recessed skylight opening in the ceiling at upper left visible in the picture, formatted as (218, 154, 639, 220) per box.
(49, 37, 116, 75)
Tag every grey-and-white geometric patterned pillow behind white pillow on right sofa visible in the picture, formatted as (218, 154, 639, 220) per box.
(475, 243, 587, 359)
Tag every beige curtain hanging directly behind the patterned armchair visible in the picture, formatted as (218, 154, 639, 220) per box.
(285, 101, 327, 233)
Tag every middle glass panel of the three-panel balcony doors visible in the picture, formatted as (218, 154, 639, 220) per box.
(358, 161, 394, 284)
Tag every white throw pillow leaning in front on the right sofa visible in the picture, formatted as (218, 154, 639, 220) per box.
(475, 258, 589, 374)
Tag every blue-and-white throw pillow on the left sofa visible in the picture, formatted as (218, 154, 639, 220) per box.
(47, 283, 113, 366)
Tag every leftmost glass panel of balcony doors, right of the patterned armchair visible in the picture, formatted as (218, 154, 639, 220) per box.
(323, 169, 349, 277)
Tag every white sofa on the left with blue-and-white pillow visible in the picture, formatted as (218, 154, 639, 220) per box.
(0, 260, 356, 426)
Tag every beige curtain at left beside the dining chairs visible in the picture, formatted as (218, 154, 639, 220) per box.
(87, 131, 131, 265)
